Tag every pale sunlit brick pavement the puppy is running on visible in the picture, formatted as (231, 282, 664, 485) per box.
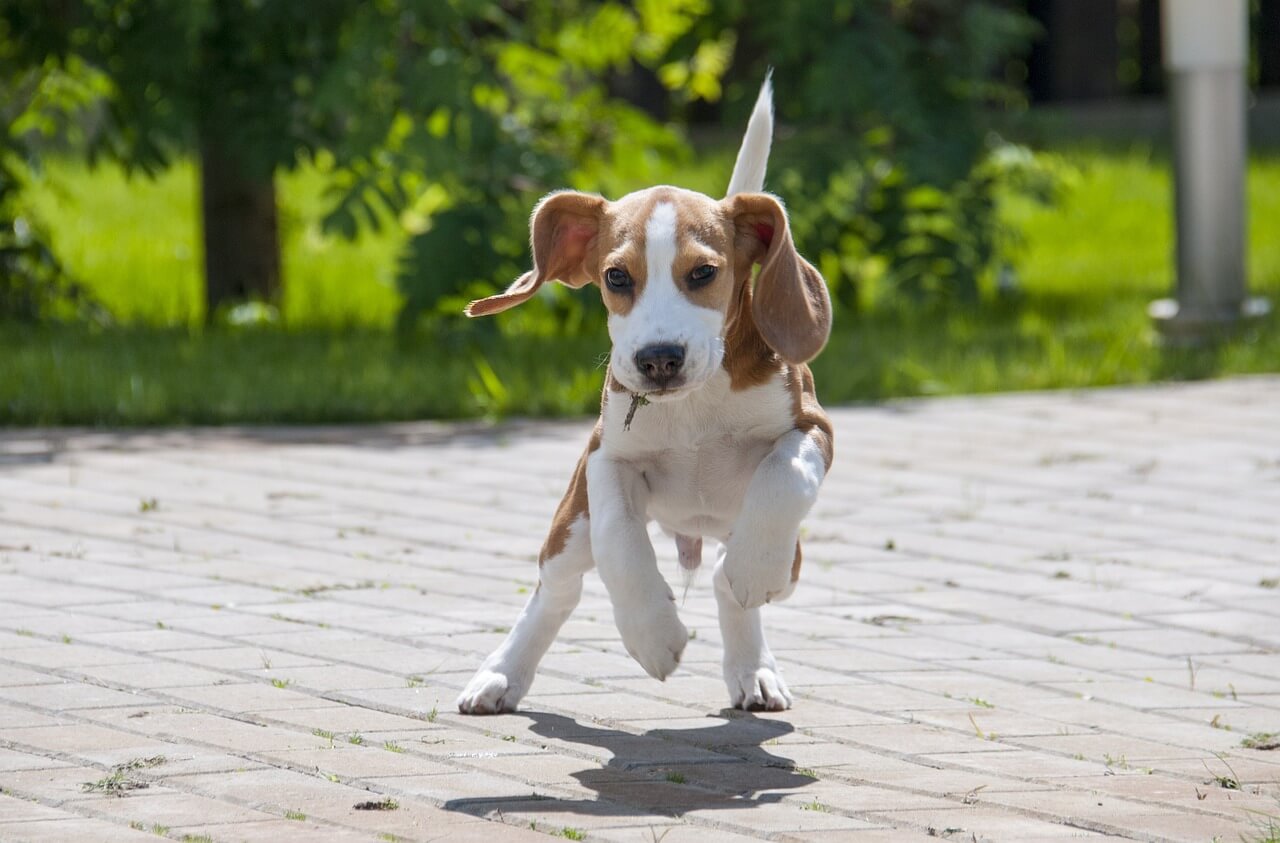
(0, 377, 1280, 843)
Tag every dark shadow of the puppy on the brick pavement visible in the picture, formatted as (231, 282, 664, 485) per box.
(444, 709, 815, 817)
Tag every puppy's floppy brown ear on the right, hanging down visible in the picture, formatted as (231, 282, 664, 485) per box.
(724, 193, 831, 363)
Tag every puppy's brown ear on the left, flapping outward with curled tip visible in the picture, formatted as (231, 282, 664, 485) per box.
(466, 191, 608, 316)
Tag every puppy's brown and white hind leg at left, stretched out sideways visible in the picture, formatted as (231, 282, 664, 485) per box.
(458, 437, 595, 714)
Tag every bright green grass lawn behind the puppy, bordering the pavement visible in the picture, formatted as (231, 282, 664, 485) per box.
(0, 148, 1280, 425)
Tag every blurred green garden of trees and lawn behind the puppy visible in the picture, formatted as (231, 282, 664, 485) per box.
(0, 0, 1280, 425)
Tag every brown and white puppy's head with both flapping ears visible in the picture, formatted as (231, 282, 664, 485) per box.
(467, 187, 831, 400)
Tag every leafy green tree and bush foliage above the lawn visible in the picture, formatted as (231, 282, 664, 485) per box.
(0, 0, 1034, 330)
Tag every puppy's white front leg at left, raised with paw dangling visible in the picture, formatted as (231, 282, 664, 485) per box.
(586, 449, 689, 679)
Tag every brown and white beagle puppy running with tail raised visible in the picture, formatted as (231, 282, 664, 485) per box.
(457, 79, 833, 714)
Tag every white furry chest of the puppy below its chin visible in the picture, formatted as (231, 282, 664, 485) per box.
(604, 374, 795, 537)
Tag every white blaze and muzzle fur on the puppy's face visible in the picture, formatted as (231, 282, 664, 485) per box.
(609, 202, 724, 391)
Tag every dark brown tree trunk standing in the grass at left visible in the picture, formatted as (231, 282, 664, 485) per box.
(200, 130, 280, 321)
